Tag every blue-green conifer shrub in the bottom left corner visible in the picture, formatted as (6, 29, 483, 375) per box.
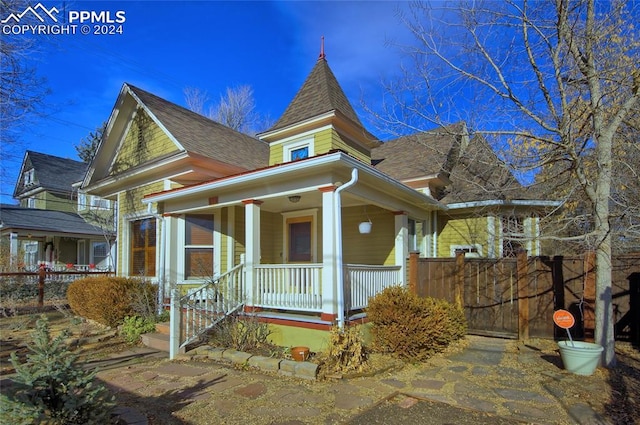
(0, 316, 114, 425)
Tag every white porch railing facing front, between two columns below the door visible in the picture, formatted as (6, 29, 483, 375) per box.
(253, 264, 322, 312)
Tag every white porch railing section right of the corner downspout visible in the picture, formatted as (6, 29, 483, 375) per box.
(344, 264, 402, 311)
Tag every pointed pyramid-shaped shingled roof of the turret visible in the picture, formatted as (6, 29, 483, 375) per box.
(268, 57, 362, 131)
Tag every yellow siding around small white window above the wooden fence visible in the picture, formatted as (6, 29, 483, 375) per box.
(438, 217, 488, 257)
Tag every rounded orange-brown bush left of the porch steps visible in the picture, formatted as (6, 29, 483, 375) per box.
(67, 276, 156, 327)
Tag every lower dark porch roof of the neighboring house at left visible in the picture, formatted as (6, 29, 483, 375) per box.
(0, 204, 103, 235)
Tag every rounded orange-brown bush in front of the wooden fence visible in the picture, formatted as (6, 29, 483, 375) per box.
(367, 286, 466, 361)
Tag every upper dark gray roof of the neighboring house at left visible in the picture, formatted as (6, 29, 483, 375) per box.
(13, 151, 87, 197)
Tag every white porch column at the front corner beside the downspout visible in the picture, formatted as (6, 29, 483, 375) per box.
(319, 186, 340, 322)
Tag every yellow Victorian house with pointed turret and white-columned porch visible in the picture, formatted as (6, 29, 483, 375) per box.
(82, 56, 560, 352)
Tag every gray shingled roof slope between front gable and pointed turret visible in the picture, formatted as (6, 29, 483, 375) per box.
(127, 84, 269, 170)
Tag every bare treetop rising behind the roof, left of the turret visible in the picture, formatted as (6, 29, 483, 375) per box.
(184, 85, 271, 135)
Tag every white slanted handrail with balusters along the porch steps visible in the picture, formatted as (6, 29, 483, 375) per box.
(169, 264, 245, 359)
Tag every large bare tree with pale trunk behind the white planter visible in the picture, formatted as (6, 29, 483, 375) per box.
(380, 0, 640, 367)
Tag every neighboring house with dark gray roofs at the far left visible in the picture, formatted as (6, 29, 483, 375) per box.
(0, 151, 115, 270)
